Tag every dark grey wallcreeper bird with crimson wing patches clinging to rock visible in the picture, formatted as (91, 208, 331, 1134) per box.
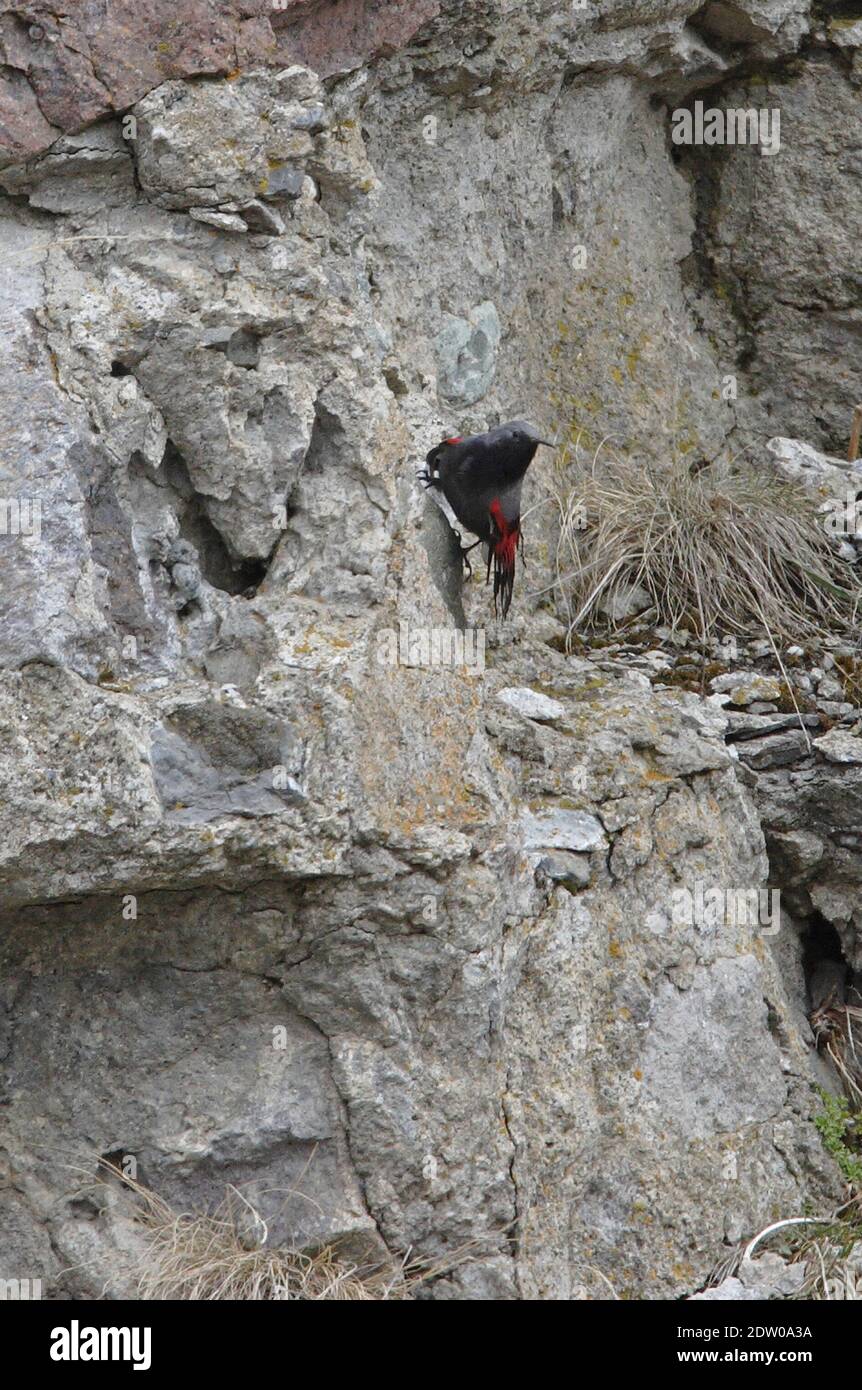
(418, 420, 553, 617)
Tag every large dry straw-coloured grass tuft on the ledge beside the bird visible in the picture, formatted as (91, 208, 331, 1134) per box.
(553, 450, 862, 642)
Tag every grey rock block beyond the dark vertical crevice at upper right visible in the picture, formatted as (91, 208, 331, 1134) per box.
(699, 65, 862, 457)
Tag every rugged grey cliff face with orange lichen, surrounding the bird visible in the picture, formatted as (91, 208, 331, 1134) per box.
(0, 0, 862, 1298)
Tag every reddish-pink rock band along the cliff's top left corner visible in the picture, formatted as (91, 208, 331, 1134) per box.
(0, 0, 439, 165)
